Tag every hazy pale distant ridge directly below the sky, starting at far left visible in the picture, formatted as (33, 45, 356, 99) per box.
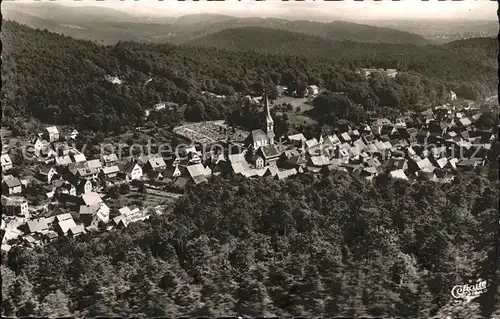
(2, 2, 429, 45)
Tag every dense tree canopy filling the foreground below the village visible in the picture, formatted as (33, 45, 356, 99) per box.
(2, 173, 500, 318)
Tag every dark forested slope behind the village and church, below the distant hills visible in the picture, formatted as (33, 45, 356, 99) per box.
(1, 22, 498, 130)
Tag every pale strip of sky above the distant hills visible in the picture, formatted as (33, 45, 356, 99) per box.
(51, 0, 498, 20)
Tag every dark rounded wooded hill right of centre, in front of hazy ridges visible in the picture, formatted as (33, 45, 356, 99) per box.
(186, 27, 498, 68)
